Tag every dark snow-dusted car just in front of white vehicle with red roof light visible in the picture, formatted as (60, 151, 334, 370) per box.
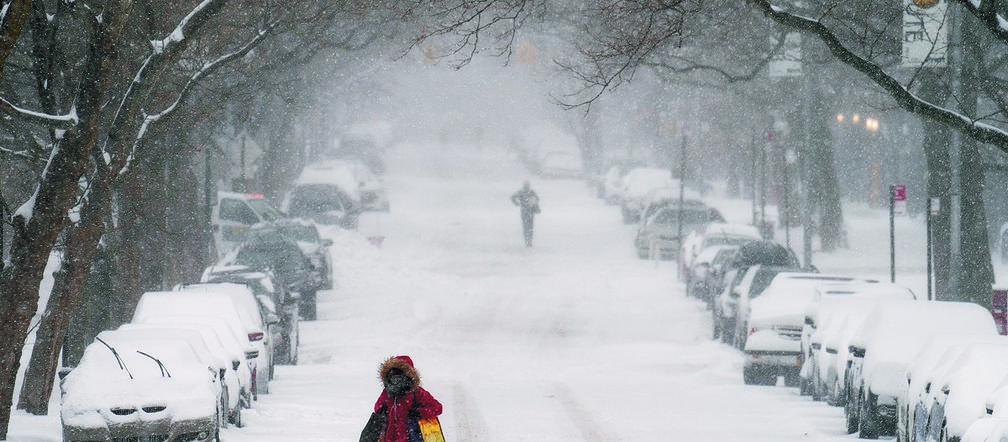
(225, 228, 322, 321)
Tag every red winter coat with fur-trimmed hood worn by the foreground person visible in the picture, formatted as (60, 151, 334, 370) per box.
(375, 356, 443, 442)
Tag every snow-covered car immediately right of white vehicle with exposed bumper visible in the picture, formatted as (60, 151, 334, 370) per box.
(799, 281, 917, 395)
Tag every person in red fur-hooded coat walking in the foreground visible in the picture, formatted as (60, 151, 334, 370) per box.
(375, 355, 443, 442)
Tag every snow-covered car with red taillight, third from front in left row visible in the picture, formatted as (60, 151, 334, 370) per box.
(132, 292, 272, 397)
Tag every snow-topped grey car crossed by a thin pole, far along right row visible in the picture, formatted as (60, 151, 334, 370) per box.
(634, 200, 711, 259)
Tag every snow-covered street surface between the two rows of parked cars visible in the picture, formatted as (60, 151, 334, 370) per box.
(223, 144, 862, 442)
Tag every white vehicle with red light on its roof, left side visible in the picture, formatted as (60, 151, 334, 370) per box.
(211, 192, 285, 257)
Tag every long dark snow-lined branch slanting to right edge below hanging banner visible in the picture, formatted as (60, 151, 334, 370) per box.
(747, 0, 1008, 152)
